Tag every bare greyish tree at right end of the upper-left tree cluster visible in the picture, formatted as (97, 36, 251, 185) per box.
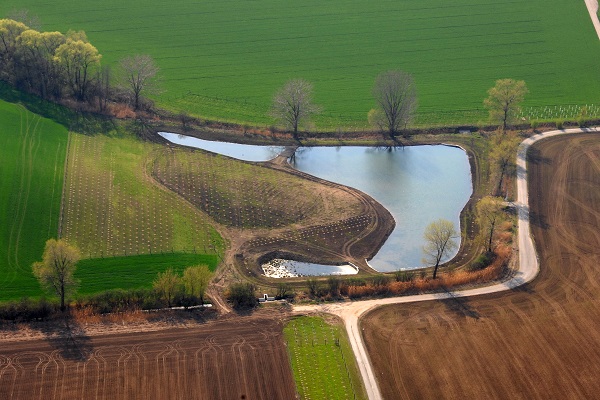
(119, 54, 159, 110)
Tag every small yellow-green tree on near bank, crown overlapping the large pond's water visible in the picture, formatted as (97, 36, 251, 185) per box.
(423, 219, 458, 279)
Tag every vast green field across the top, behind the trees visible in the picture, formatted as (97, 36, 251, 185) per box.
(0, 0, 600, 129)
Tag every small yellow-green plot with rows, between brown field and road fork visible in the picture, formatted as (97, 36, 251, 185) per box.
(283, 317, 366, 400)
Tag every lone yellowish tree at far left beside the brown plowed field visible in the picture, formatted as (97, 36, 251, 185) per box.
(32, 239, 81, 311)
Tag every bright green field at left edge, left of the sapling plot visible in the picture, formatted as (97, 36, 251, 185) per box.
(0, 100, 68, 299)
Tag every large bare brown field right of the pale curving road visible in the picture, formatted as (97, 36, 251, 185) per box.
(362, 134, 600, 399)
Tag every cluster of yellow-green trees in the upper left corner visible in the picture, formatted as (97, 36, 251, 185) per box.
(0, 19, 158, 112)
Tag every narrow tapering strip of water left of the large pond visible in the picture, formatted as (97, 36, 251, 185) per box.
(158, 132, 285, 162)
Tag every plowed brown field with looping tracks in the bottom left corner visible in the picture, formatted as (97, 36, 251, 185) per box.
(0, 317, 296, 400)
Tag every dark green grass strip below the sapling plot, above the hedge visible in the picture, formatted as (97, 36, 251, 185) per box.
(75, 253, 219, 295)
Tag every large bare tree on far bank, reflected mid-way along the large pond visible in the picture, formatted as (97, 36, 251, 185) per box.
(372, 71, 417, 139)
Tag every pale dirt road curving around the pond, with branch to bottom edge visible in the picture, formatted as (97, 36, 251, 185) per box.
(294, 128, 600, 400)
